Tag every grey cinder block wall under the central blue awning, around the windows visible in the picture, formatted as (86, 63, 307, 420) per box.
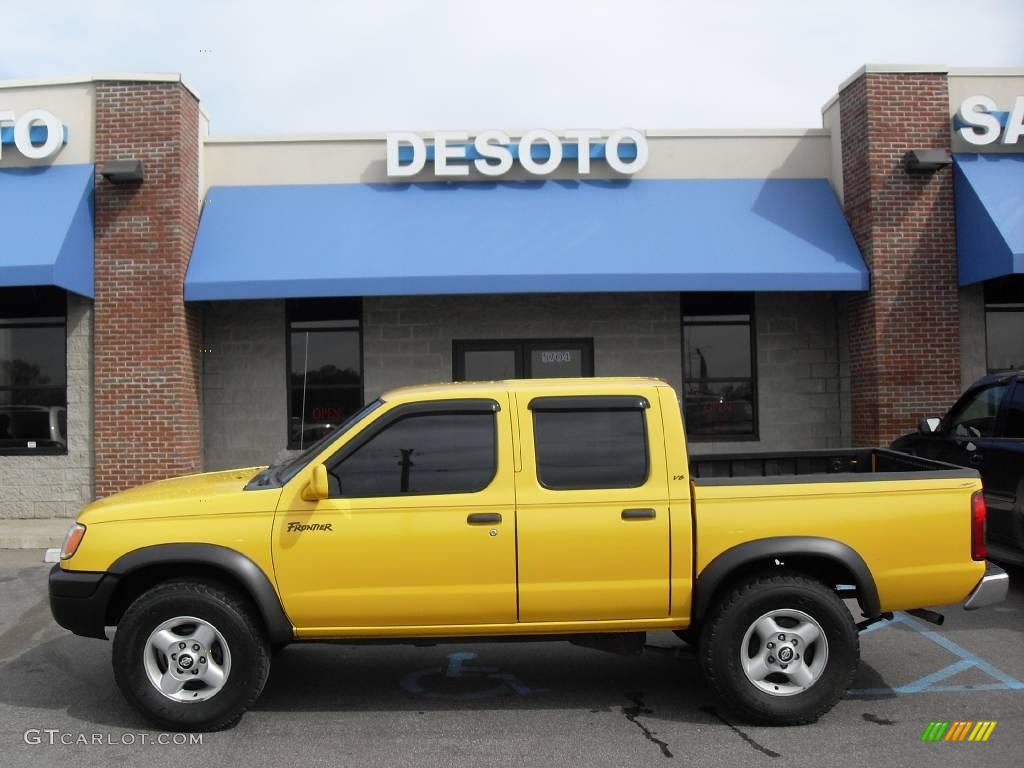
(197, 293, 849, 470)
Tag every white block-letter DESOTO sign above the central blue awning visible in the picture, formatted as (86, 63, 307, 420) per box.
(387, 128, 648, 176)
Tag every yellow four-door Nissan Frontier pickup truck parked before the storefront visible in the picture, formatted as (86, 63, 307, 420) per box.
(49, 378, 1008, 730)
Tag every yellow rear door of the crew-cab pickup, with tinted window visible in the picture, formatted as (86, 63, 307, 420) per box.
(515, 389, 671, 622)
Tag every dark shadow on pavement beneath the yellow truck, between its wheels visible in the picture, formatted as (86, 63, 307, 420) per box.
(255, 643, 712, 722)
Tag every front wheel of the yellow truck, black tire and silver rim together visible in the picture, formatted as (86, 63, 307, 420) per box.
(112, 580, 270, 731)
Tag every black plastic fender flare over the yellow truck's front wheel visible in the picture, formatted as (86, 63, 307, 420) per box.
(106, 544, 295, 645)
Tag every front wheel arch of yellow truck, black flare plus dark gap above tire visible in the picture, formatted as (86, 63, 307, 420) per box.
(105, 544, 294, 645)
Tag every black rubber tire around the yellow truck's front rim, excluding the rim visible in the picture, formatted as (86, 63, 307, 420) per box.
(113, 580, 270, 731)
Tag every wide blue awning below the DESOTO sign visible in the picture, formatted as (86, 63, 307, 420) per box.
(185, 179, 868, 300)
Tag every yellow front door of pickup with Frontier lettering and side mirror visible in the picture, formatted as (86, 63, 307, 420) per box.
(272, 392, 516, 637)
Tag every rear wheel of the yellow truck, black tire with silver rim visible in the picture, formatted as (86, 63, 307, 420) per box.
(700, 575, 860, 725)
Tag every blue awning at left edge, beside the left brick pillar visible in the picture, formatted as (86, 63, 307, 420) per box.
(0, 164, 93, 297)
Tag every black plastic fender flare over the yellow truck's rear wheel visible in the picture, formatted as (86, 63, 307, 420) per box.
(692, 536, 882, 621)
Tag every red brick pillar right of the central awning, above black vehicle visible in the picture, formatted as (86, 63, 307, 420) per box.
(840, 72, 959, 445)
